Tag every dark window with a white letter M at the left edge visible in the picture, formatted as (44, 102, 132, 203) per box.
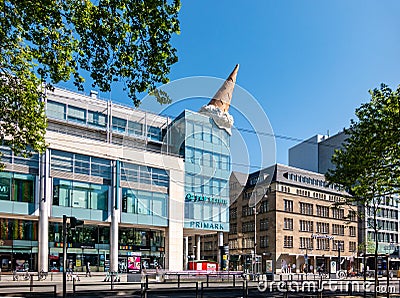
(0, 172, 35, 203)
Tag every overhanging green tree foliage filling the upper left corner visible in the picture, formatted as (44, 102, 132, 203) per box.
(0, 0, 180, 158)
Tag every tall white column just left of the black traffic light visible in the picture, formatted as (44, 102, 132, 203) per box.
(38, 150, 51, 272)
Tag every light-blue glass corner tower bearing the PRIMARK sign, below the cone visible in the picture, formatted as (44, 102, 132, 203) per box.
(171, 111, 231, 231)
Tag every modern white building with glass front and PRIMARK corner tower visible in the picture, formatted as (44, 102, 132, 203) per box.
(0, 64, 238, 272)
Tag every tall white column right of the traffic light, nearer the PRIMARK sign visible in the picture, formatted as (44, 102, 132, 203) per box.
(110, 160, 120, 271)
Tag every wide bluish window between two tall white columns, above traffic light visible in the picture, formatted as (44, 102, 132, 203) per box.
(53, 178, 109, 211)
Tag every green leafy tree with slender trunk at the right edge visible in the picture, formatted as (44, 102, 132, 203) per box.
(326, 84, 400, 296)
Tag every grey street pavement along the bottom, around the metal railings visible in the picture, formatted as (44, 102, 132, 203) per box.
(0, 272, 400, 298)
